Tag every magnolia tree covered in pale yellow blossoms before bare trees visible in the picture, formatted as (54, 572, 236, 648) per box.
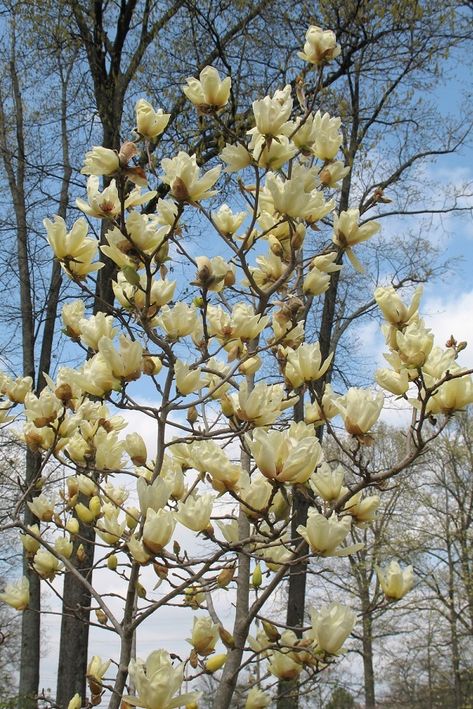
(1, 26, 473, 709)
